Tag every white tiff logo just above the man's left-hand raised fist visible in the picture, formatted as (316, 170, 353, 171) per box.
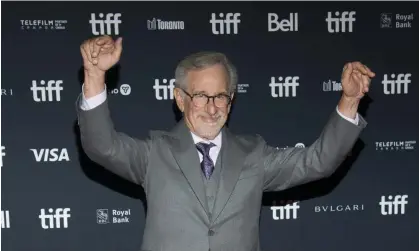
(89, 13, 122, 35)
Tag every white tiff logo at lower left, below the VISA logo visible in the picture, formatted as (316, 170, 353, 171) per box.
(39, 208, 71, 229)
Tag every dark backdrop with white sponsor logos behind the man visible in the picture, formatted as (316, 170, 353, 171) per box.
(1, 2, 419, 251)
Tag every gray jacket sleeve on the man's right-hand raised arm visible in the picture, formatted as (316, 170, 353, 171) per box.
(261, 111, 367, 191)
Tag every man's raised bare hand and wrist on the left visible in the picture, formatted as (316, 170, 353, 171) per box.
(80, 36, 122, 98)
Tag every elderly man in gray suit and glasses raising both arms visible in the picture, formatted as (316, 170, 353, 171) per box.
(78, 36, 374, 251)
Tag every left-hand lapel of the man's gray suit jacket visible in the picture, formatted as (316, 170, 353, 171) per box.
(170, 119, 209, 214)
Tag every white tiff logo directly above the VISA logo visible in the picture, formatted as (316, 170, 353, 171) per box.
(31, 80, 64, 102)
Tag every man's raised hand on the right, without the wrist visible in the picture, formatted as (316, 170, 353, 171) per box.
(342, 62, 375, 99)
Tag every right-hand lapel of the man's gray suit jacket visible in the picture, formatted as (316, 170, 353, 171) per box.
(212, 128, 246, 221)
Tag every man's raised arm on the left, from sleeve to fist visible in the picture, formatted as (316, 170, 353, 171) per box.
(76, 36, 151, 185)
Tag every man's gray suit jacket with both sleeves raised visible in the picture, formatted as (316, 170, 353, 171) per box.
(78, 98, 366, 251)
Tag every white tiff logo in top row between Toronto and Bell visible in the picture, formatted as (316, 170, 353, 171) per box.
(210, 13, 241, 35)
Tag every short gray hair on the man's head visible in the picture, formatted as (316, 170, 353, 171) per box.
(175, 51, 237, 93)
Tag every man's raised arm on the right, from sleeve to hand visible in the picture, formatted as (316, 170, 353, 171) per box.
(260, 62, 375, 191)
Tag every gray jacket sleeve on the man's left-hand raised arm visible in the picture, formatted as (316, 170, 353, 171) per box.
(76, 96, 152, 185)
